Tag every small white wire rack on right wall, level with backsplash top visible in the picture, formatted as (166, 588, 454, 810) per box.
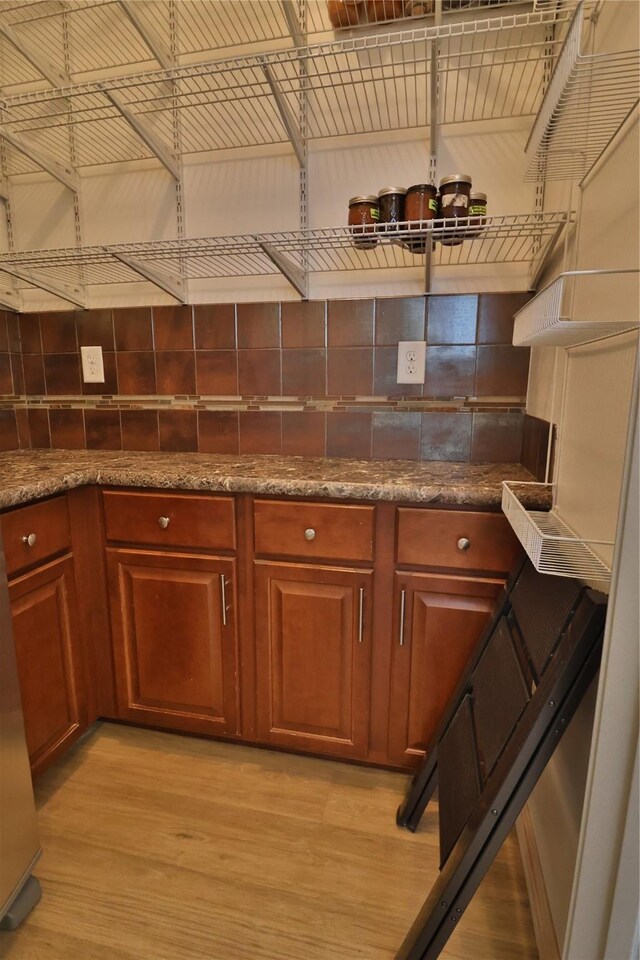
(513, 269, 640, 347)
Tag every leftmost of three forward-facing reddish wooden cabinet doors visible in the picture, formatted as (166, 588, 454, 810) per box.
(106, 550, 238, 734)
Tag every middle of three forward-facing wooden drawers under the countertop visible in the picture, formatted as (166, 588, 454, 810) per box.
(254, 500, 375, 560)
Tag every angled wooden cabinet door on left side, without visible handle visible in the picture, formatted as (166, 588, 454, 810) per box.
(9, 557, 86, 773)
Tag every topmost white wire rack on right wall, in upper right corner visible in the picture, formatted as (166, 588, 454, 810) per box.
(526, 4, 640, 180)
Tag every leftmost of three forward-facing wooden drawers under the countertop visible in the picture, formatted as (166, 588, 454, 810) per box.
(103, 490, 236, 550)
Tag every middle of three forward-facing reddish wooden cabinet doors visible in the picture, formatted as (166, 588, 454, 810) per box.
(255, 562, 372, 758)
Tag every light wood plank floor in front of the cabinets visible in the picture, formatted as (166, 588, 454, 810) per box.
(0, 723, 537, 960)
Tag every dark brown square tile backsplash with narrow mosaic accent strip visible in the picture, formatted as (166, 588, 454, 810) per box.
(0, 293, 529, 462)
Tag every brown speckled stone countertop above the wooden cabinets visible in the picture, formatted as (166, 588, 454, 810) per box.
(0, 450, 544, 508)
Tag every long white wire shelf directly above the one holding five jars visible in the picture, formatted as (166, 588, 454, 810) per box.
(0, 8, 566, 176)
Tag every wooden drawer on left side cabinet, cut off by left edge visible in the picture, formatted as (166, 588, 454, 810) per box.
(0, 497, 71, 577)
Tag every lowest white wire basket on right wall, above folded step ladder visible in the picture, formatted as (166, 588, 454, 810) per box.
(502, 480, 613, 583)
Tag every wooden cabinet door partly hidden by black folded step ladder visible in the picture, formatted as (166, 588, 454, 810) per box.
(389, 573, 504, 767)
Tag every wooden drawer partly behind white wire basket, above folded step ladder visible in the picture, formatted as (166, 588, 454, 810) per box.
(397, 507, 521, 573)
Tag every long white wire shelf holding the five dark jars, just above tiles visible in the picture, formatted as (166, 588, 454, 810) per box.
(0, 213, 567, 309)
